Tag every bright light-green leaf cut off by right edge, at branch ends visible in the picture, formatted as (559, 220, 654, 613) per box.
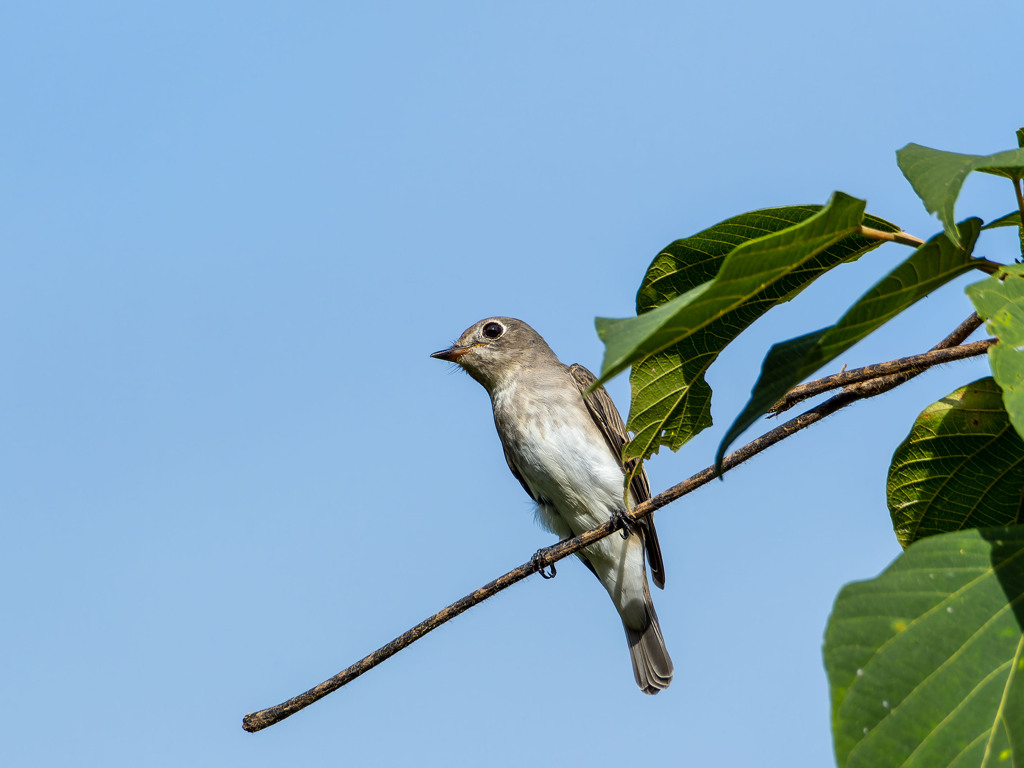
(967, 264, 1024, 435)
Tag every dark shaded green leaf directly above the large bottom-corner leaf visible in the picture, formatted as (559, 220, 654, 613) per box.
(886, 377, 1024, 547)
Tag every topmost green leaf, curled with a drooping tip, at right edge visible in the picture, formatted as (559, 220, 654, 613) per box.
(896, 144, 1024, 245)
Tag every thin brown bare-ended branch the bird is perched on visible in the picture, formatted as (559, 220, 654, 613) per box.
(242, 318, 991, 732)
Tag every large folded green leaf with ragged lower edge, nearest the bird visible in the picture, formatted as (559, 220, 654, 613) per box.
(597, 193, 899, 458)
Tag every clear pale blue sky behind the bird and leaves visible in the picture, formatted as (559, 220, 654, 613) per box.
(0, 0, 1024, 766)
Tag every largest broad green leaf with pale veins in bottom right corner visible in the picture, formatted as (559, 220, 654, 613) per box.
(824, 525, 1024, 768)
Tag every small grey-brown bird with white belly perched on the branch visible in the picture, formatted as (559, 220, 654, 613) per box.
(430, 317, 672, 693)
